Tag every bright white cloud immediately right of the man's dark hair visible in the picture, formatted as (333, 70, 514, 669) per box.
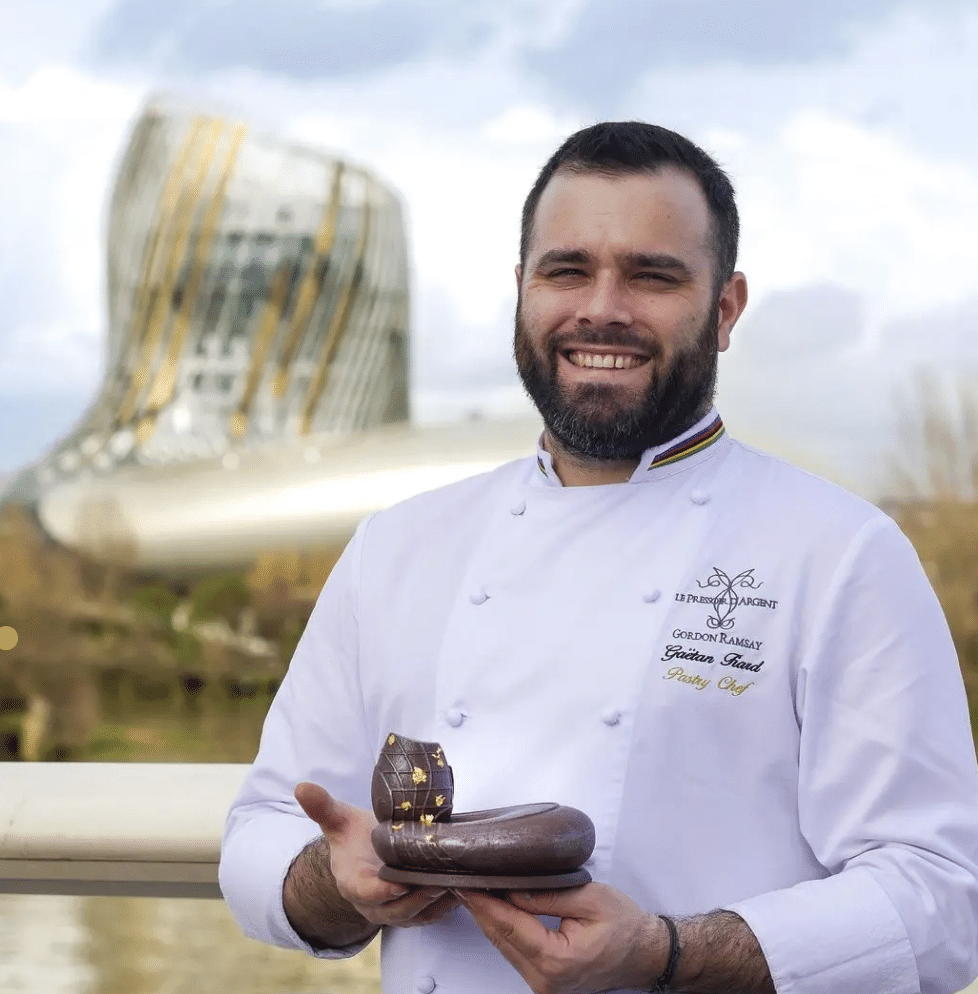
(714, 110, 978, 324)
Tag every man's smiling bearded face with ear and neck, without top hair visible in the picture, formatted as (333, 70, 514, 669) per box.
(514, 155, 747, 484)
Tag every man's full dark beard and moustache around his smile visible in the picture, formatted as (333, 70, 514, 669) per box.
(513, 300, 720, 462)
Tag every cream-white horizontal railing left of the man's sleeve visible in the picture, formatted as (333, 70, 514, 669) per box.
(0, 763, 248, 898)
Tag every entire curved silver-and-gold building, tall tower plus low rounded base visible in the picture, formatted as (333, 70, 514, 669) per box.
(3, 101, 539, 571)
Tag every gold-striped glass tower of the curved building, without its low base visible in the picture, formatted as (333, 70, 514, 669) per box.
(9, 103, 409, 491)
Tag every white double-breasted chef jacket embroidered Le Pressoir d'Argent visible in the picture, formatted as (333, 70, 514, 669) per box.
(220, 412, 978, 994)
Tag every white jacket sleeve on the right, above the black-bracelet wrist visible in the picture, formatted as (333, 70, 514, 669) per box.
(728, 518, 978, 994)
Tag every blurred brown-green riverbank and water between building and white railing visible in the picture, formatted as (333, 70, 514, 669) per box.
(0, 508, 338, 762)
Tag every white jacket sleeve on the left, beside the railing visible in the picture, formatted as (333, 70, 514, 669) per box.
(219, 522, 373, 959)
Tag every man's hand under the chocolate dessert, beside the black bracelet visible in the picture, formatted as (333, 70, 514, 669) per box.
(457, 883, 669, 994)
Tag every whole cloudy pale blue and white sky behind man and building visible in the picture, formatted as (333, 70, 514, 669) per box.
(0, 0, 978, 491)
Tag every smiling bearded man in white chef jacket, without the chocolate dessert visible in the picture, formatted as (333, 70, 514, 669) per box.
(221, 123, 978, 994)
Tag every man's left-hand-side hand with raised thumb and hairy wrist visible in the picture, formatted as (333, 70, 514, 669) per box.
(283, 783, 459, 947)
